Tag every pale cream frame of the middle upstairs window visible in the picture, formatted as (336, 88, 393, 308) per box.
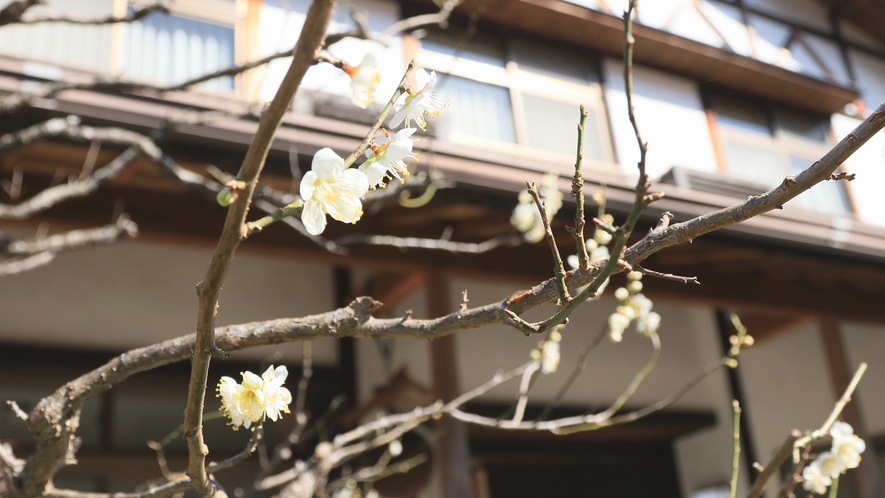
(415, 27, 620, 171)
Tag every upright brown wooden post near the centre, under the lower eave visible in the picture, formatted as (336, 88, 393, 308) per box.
(427, 271, 472, 498)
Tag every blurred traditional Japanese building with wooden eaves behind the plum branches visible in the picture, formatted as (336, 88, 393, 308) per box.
(0, 0, 885, 498)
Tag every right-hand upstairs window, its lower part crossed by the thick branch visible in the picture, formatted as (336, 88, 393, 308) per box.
(709, 95, 852, 215)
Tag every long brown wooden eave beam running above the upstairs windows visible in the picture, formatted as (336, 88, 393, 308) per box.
(442, 0, 859, 113)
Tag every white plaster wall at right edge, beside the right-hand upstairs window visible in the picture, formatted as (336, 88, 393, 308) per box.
(832, 113, 885, 226)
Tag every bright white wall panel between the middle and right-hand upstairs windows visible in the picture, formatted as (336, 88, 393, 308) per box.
(603, 58, 716, 179)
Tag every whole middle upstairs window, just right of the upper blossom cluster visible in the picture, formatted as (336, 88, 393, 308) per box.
(418, 28, 613, 165)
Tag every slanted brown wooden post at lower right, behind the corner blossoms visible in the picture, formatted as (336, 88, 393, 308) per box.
(818, 317, 883, 498)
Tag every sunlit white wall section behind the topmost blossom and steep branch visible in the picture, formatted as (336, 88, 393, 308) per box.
(261, 0, 405, 105)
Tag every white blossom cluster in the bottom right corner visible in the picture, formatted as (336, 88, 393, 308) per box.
(802, 422, 866, 495)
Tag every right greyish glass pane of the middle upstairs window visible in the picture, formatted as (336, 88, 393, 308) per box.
(523, 94, 604, 161)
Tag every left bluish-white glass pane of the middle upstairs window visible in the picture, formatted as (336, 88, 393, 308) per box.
(439, 75, 516, 143)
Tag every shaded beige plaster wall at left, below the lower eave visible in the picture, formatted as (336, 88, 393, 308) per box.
(0, 230, 337, 365)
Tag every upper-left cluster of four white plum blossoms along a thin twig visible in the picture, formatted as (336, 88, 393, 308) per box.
(300, 62, 448, 235)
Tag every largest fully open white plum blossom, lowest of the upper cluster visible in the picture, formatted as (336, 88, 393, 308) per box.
(301, 148, 369, 235)
